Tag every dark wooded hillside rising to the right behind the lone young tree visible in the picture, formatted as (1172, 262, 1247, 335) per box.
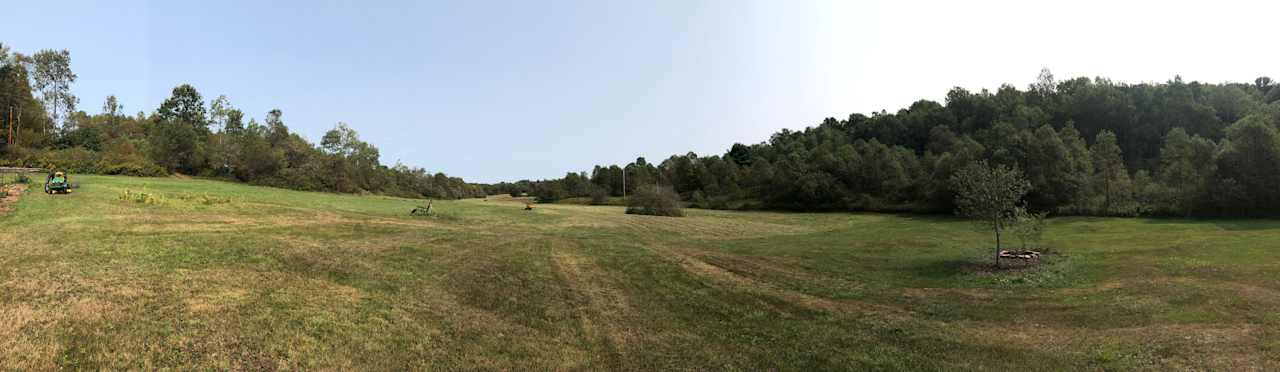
(488, 69, 1280, 216)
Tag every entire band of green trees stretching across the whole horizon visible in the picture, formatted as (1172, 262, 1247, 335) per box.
(0, 43, 1280, 217)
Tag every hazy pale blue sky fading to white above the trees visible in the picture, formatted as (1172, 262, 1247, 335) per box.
(0, 0, 1280, 183)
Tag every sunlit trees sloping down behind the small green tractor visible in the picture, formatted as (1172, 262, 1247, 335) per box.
(0, 43, 484, 198)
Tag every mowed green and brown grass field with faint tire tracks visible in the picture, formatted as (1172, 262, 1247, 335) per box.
(0, 176, 1280, 371)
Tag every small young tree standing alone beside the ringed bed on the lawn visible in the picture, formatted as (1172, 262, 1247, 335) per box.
(951, 161, 1032, 266)
